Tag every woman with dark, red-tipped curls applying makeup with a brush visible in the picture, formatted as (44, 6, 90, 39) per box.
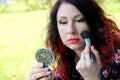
(28, 0, 120, 80)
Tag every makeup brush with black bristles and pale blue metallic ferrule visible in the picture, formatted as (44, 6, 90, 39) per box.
(80, 30, 95, 63)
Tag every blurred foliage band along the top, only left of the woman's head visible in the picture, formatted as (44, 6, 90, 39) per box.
(0, 0, 54, 12)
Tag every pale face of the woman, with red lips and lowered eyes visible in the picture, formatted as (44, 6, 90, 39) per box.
(57, 3, 89, 51)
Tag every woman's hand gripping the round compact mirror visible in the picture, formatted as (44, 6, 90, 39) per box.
(27, 63, 50, 80)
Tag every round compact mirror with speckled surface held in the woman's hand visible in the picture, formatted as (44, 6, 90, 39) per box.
(35, 47, 54, 67)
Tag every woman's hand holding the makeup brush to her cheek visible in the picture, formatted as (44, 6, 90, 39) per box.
(76, 45, 101, 80)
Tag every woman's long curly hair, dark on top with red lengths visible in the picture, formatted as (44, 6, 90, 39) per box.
(46, 0, 120, 80)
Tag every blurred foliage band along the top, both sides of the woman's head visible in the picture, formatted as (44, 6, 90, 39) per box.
(0, 0, 120, 13)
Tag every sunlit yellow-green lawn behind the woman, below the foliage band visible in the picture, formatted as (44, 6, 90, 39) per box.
(0, 11, 120, 80)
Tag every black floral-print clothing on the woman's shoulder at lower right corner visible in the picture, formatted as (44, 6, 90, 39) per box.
(101, 49, 120, 80)
